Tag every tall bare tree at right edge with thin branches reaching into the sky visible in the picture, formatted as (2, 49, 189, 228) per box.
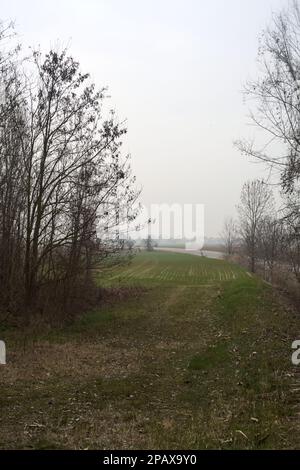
(237, 0, 300, 235)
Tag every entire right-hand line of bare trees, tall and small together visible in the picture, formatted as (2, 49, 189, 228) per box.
(223, 0, 300, 291)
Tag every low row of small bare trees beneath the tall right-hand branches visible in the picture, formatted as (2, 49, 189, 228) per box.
(222, 180, 300, 284)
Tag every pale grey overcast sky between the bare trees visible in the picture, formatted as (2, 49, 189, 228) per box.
(1, 0, 287, 236)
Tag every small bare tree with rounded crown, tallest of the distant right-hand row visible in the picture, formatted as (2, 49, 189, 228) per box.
(238, 180, 273, 272)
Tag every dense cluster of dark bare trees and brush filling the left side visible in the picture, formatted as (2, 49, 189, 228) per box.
(0, 24, 138, 318)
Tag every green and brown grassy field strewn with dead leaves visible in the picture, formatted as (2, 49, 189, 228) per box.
(0, 252, 300, 449)
